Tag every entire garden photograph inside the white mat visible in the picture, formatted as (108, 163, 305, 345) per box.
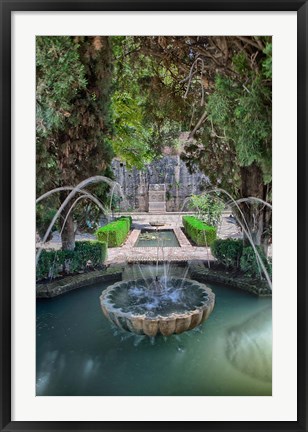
(36, 36, 272, 396)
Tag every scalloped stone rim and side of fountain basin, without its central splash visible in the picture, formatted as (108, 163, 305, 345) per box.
(100, 278, 215, 336)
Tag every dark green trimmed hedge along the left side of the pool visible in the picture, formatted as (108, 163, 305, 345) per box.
(36, 241, 107, 280)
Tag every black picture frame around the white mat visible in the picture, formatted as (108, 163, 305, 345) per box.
(0, 0, 308, 432)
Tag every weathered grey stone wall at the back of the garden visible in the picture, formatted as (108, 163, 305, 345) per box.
(112, 155, 208, 211)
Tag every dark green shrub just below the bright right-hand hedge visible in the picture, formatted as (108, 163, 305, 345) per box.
(211, 239, 243, 268)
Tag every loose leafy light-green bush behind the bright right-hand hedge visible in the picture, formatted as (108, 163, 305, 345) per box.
(190, 195, 224, 227)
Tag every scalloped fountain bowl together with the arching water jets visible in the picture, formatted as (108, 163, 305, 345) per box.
(36, 176, 271, 337)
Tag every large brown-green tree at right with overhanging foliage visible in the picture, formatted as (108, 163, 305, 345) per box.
(127, 36, 272, 245)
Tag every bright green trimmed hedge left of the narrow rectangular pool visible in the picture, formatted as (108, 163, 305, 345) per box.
(95, 216, 132, 247)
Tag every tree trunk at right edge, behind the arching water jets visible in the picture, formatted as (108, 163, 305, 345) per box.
(240, 163, 271, 251)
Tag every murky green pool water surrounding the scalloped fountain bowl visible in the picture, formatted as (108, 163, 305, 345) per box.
(36, 267, 272, 396)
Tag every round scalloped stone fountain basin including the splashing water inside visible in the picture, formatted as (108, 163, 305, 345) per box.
(100, 277, 215, 336)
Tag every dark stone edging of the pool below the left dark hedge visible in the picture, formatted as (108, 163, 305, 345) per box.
(36, 267, 122, 298)
